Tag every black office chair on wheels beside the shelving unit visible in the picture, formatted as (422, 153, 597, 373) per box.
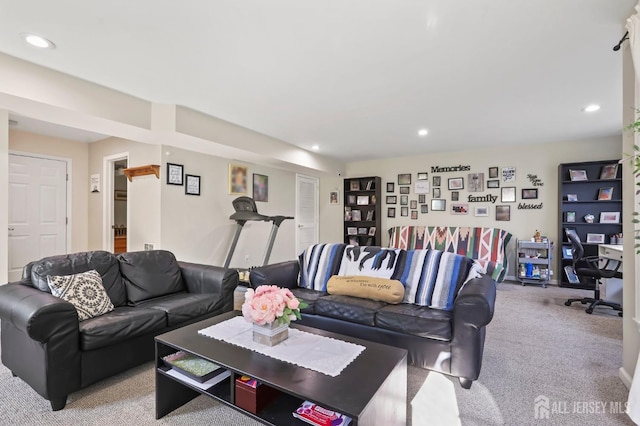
(564, 232, 622, 316)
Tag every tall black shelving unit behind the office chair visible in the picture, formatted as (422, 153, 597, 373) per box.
(557, 159, 622, 289)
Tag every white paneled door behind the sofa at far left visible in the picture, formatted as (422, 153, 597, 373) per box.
(9, 154, 67, 281)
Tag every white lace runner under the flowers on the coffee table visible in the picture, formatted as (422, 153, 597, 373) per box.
(198, 316, 365, 377)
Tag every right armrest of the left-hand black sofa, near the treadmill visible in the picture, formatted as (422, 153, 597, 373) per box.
(178, 262, 240, 312)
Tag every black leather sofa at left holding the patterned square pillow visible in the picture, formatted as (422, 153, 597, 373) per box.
(0, 250, 238, 411)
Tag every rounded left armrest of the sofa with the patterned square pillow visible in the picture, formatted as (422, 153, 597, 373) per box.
(0, 282, 79, 343)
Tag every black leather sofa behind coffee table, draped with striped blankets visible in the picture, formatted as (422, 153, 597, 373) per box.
(250, 260, 496, 389)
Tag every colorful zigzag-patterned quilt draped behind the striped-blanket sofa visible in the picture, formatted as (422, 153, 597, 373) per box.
(389, 226, 512, 283)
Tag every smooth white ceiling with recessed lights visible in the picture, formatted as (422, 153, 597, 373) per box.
(0, 0, 636, 161)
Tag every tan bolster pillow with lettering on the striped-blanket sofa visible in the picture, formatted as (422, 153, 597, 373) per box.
(327, 275, 404, 304)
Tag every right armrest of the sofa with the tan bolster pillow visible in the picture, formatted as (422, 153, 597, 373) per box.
(453, 275, 496, 328)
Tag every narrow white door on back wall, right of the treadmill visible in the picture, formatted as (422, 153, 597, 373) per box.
(296, 175, 319, 255)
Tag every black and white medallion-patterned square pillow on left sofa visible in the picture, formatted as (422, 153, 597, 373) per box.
(47, 270, 113, 321)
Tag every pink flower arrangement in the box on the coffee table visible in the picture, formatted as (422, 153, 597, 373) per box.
(242, 285, 308, 325)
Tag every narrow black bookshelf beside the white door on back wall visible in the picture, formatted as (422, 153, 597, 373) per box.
(343, 176, 382, 246)
